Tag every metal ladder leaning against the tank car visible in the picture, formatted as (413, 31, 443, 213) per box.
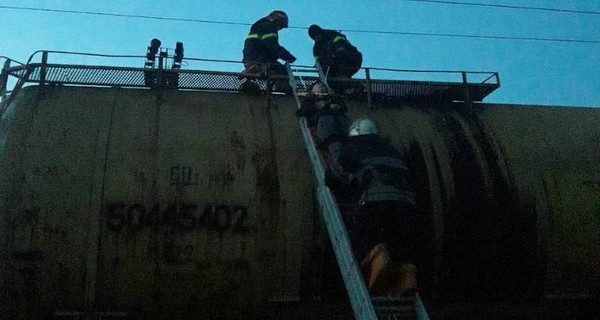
(286, 63, 429, 320)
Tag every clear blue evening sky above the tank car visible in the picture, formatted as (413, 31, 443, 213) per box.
(0, 0, 600, 107)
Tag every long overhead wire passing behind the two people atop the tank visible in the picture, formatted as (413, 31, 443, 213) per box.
(0, 4, 600, 44)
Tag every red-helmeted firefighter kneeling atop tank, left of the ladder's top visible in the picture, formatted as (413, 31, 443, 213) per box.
(242, 10, 296, 93)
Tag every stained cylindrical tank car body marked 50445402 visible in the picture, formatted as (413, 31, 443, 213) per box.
(0, 56, 600, 319)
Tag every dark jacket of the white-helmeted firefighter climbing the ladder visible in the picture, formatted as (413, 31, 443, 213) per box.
(327, 134, 415, 206)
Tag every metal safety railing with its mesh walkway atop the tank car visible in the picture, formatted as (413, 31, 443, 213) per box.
(0, 50, 500, 119)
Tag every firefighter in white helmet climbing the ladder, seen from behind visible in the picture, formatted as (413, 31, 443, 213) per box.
(326, 118, 417, 296)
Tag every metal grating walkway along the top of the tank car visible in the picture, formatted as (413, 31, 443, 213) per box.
(8, 63, 500, 101)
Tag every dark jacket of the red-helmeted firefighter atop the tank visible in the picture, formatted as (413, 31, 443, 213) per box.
(243, 18, 293, 63)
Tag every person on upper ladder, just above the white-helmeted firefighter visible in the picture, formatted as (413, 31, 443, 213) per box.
(296, 82, 350, 161)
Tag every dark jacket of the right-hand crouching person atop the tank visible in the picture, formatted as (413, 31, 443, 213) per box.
(313, 29, 362, 65)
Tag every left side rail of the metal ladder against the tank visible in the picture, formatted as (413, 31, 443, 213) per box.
(286, 63, 377, 320)
